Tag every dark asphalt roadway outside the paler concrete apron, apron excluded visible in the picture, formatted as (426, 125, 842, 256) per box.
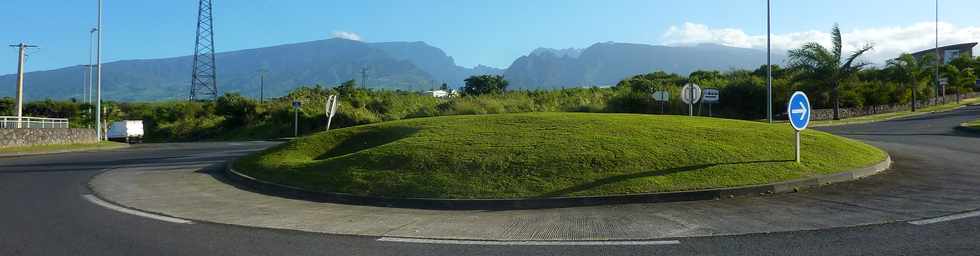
(0, 107, 980, 255)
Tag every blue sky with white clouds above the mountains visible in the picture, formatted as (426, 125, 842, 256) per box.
(0, 0, 980, 74)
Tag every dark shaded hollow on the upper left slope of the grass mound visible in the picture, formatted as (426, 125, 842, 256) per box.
(316, 127, 419, 160)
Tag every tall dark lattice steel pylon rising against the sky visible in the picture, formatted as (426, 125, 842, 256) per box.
(190, 0, 218, 100)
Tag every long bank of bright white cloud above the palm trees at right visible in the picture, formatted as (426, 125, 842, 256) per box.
(661, 22, 980, 64)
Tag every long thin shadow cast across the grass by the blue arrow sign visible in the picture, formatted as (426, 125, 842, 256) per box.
(541, 160, 795, 197)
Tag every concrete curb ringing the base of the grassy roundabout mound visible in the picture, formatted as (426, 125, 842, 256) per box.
(225, 155, 892, 210)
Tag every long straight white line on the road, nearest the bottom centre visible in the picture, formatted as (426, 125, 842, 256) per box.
(378, 237, 681, 246)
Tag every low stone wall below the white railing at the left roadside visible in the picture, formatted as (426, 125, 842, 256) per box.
(0, 128, 99, 148)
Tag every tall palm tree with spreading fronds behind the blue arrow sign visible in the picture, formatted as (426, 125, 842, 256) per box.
(789, 24, 873, 120)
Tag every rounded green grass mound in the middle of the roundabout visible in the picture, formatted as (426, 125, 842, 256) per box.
(235, 113, 885, 198)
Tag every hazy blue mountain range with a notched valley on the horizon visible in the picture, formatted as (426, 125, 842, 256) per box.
(0, 38, 784, 101)
